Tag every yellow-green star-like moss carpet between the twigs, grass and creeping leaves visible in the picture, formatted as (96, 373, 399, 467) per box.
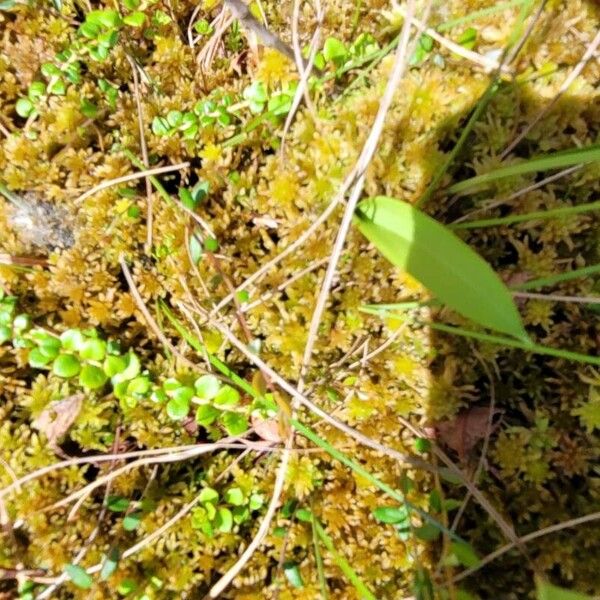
(0, 0, 600, 599)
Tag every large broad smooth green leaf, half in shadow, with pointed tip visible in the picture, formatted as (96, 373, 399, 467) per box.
(355, 196, 529, 342)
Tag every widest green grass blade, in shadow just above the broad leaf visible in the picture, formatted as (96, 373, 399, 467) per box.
(448, 144, 600, 194)
